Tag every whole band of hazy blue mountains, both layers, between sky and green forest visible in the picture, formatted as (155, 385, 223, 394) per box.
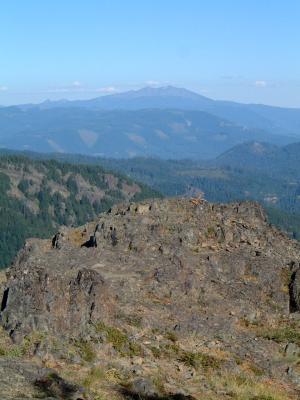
(0, 86, 300, 159)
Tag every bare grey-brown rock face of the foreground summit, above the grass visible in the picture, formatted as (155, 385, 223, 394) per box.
(1, 199, 300, 340)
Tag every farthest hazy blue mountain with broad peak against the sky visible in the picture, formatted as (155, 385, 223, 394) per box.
(18, 86, 300, 137)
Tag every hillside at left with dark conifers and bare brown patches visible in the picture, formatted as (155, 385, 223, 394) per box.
(0, 155, 159, 268)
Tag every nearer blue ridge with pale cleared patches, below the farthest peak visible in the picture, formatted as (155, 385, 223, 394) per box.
(0, 106, 294, 159)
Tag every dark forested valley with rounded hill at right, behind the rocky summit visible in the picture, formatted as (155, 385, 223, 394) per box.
(3, 142, 300, 239)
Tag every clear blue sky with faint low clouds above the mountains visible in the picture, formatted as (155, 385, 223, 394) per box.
(0, 0, 300, 108)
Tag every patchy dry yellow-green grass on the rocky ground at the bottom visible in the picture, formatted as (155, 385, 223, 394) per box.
(0, 322, 298, 400)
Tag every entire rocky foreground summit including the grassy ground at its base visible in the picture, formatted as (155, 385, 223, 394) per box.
(0, 199, 300, 400)
